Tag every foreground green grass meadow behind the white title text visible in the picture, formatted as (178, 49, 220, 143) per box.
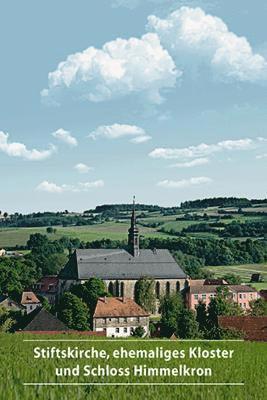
(0, 334, 267, 400)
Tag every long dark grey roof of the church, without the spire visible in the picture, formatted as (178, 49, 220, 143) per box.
(59, 249, 186, 280)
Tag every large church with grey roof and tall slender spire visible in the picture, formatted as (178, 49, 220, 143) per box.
(59, 202, 187, 299)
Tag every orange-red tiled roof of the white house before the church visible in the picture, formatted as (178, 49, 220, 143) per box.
(94, 297, 149, 318)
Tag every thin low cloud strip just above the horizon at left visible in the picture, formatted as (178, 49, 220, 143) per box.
(36, 180, 104, 193)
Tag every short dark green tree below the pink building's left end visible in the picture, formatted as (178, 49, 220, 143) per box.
(176, 308, 199, 339)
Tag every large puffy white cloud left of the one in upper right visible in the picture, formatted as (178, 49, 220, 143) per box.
(41, 33, 182, 103)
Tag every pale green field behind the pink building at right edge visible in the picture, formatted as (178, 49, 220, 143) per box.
(205, 264, 267, 290)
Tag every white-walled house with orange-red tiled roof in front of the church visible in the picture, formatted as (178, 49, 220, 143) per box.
(93, 297, 149, 337)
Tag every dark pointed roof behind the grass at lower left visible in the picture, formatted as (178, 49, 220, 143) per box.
(23, 307, 69, 333)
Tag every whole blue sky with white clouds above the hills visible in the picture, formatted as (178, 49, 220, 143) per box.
(0, 0, 267, 213)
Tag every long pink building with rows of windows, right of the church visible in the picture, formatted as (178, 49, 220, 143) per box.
(186, 285, 258, 310)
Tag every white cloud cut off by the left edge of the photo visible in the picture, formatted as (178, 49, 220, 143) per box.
(0, 131, 56, 161)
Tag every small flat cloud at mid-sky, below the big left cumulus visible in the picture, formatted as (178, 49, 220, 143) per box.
(88, 124, 151, 143)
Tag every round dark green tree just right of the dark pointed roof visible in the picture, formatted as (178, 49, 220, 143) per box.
(58, 292, 89, 331)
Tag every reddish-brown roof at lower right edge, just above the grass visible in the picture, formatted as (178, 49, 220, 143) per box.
(218, 316, 267, 342)
